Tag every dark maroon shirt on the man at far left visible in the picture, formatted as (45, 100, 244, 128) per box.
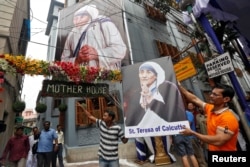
(2, 135, 30, 161)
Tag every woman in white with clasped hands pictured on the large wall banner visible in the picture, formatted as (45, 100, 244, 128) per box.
(61, 4, 127, 70)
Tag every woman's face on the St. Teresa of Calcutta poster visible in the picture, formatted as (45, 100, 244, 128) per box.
(139, 69, 157, 87)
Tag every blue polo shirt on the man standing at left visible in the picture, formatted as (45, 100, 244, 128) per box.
(37, 129, 58, 152)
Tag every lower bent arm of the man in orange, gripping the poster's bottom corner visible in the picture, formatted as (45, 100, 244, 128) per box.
(180, 127, 233, 146)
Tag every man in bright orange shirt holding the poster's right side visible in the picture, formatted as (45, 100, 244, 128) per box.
(179, 83, 239, 151)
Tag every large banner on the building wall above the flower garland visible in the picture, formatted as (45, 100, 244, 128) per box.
(55, 0, 128, 70)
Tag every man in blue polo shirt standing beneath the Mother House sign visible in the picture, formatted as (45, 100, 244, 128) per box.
(37, 121, 58, 167)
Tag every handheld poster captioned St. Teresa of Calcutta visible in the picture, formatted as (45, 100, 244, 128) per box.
(122, 57, 189, 137)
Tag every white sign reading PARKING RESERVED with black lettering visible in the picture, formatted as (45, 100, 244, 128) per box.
(205, 52, 234, 78)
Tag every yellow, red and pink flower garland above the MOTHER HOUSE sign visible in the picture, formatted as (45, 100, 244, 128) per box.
(0, 54, 122, 83)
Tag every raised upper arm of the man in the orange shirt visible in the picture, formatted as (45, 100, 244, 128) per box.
(179, 84, 205, 109)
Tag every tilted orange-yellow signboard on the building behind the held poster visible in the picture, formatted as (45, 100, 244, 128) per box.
(174, 56, 197, 81)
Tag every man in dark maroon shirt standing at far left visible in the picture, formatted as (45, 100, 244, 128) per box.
(0, 126, 30, 167)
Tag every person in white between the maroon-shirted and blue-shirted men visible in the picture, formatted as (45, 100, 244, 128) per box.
(26, 127, 40, 167)
